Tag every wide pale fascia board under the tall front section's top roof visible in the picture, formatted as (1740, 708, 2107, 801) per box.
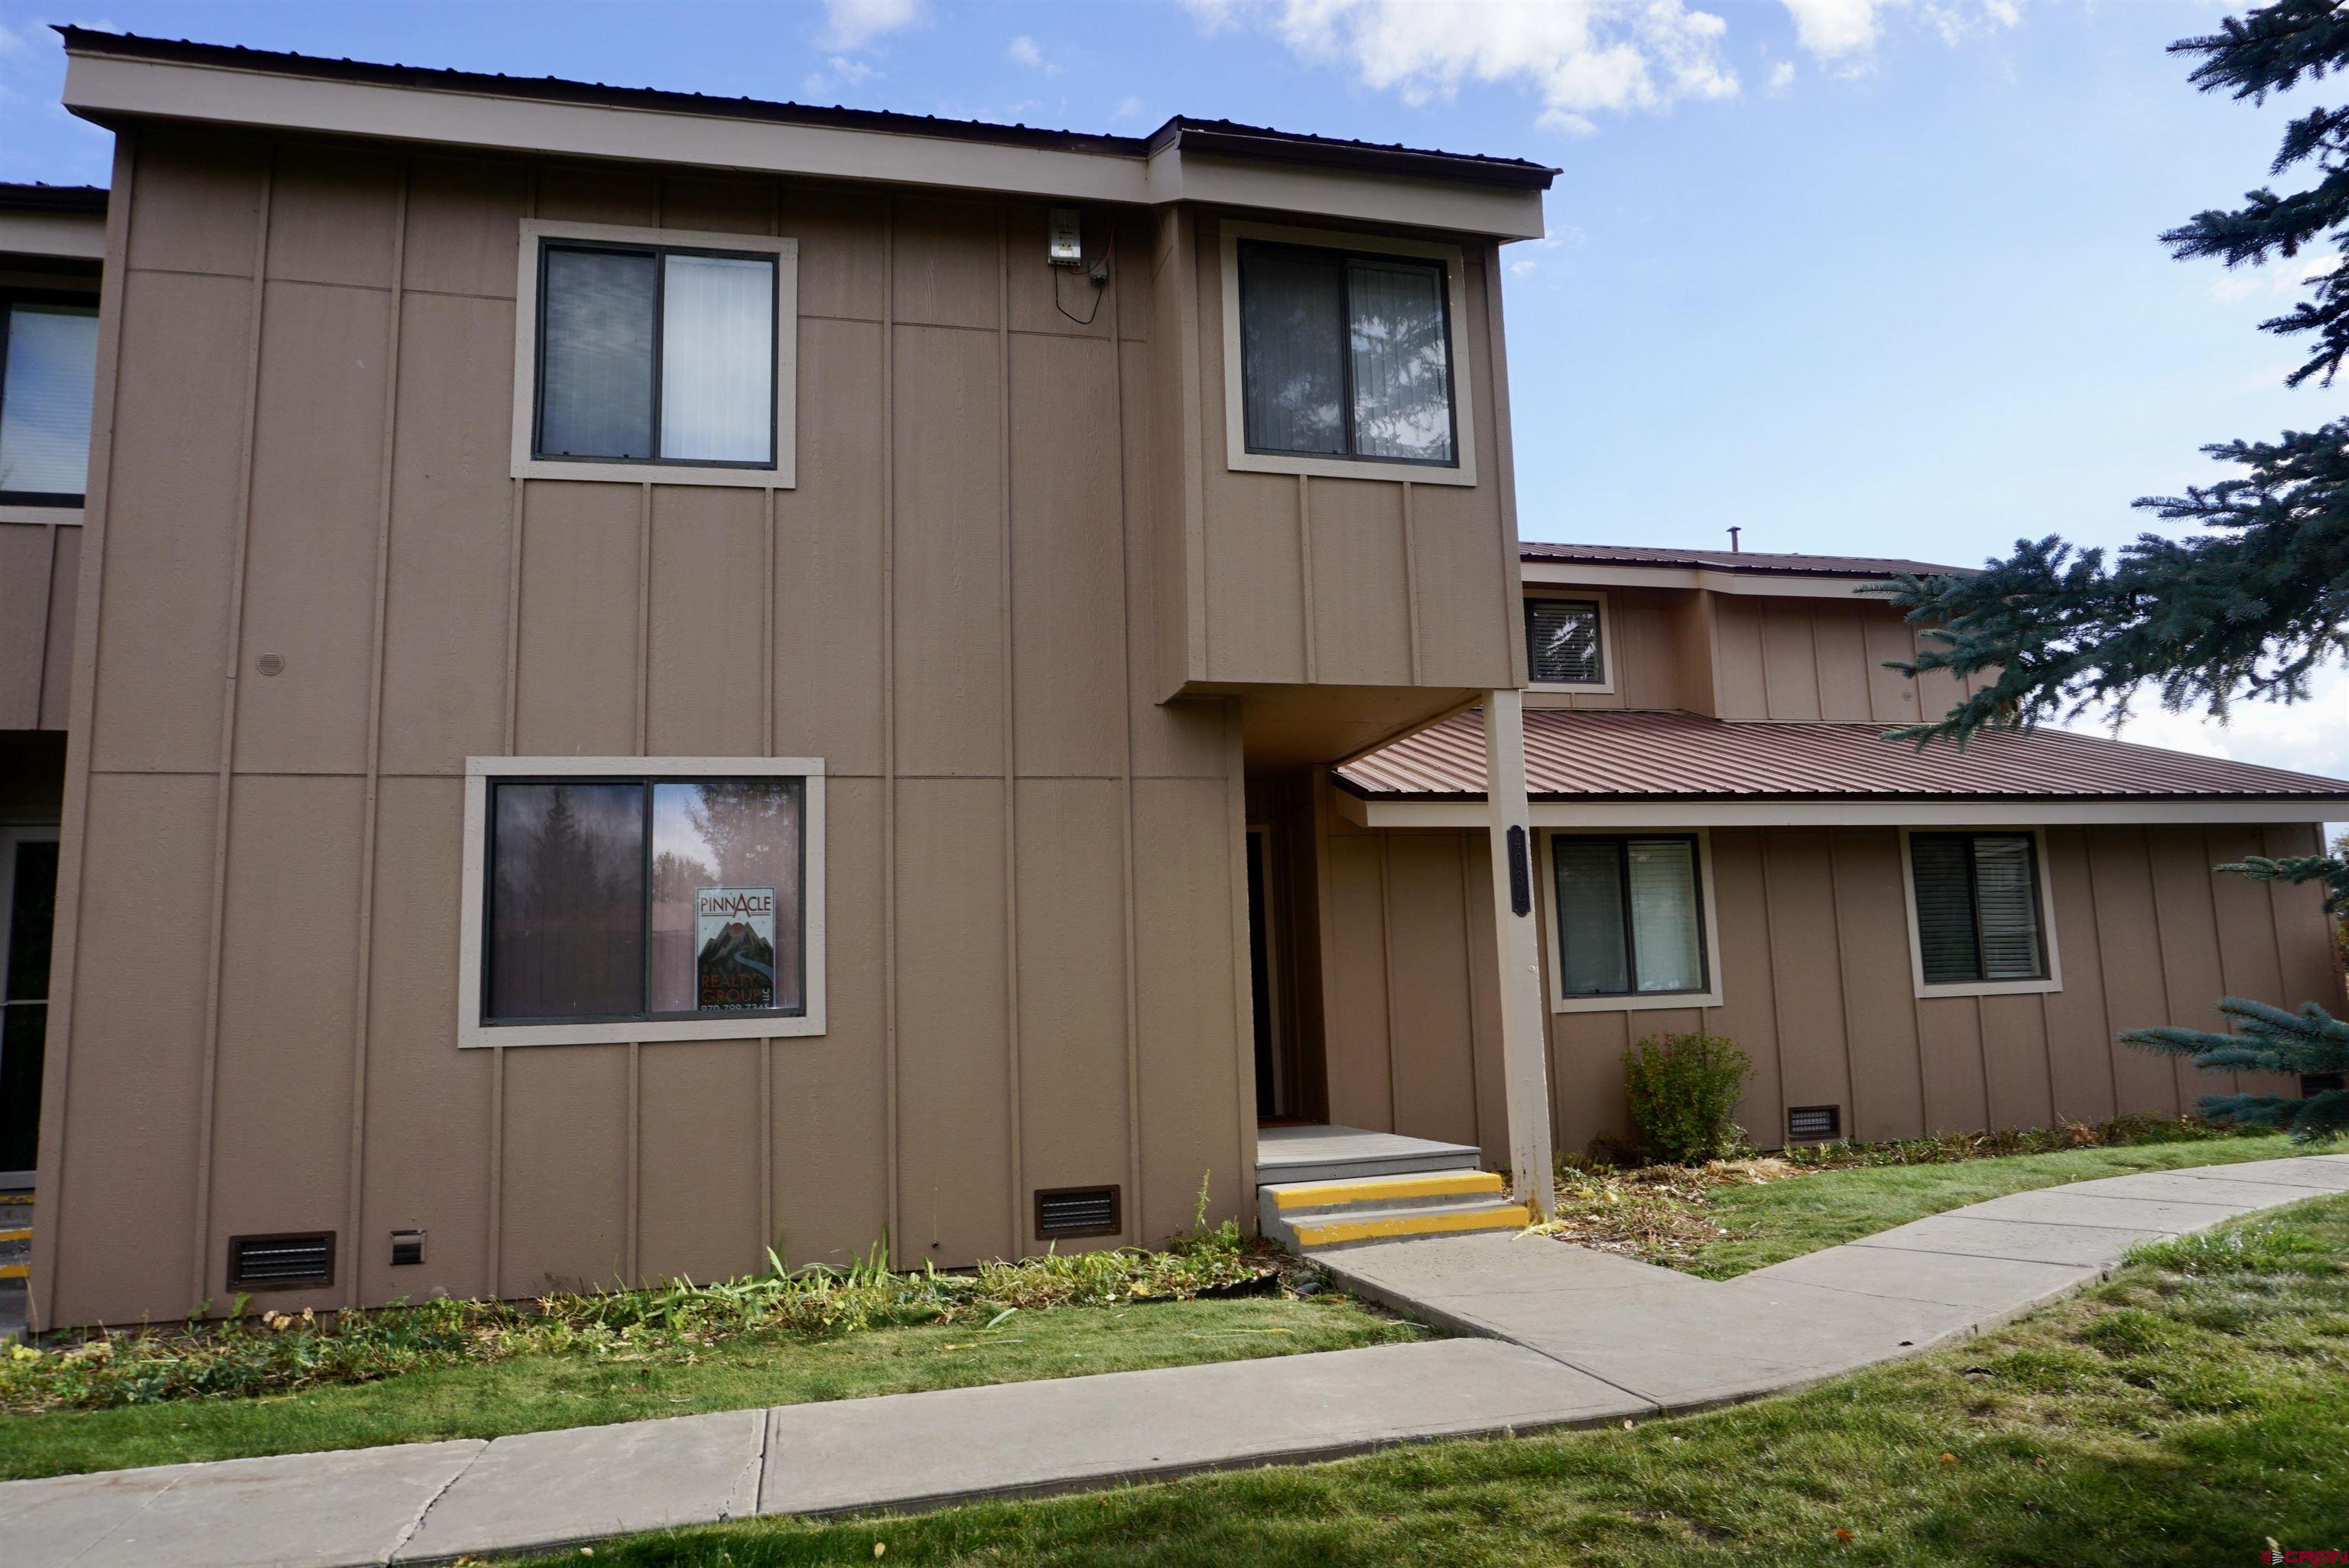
(63, 54, 1541, 239)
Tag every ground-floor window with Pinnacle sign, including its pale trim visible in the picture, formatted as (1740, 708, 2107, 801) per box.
(465, 758, 822, 1044)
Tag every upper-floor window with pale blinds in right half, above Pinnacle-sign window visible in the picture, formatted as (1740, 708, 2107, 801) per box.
(531, 242, 775, 467)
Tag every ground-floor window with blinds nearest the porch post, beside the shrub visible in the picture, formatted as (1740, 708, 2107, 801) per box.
(1551, 833, 1707, 998)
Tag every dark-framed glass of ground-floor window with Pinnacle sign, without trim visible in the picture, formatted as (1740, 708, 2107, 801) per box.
(484, 777, 806, 1024)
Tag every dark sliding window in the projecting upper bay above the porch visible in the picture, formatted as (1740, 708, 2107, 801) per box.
(1240, 244, 1459, 467)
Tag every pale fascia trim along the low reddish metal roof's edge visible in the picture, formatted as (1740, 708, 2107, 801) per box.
(1332, 789, 2349, 829)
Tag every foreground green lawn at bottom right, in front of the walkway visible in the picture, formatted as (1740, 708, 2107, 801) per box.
(495, 1187, 2349, 1568)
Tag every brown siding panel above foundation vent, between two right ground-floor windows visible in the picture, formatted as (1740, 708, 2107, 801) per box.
(1762, 830, 1851, 1136)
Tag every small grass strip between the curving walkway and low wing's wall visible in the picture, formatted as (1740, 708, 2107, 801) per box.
(1701, 1136, 2302, 1277)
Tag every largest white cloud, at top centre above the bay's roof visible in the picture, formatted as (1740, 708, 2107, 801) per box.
(1186, 0, 1738, 134)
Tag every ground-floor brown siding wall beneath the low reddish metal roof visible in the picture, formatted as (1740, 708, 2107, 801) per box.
(1323, 812, 2342, 1160)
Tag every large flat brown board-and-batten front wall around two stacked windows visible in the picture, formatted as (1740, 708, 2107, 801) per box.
(35, 129, 1249, 1322)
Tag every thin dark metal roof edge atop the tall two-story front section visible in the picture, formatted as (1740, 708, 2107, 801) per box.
(57, 26, 1558, 190)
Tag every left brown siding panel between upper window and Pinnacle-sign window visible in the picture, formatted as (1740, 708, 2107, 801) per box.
(515, 479, 644, 756)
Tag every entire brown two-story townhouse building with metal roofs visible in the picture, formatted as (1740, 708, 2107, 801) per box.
(18, 28, 2349, 1324)
